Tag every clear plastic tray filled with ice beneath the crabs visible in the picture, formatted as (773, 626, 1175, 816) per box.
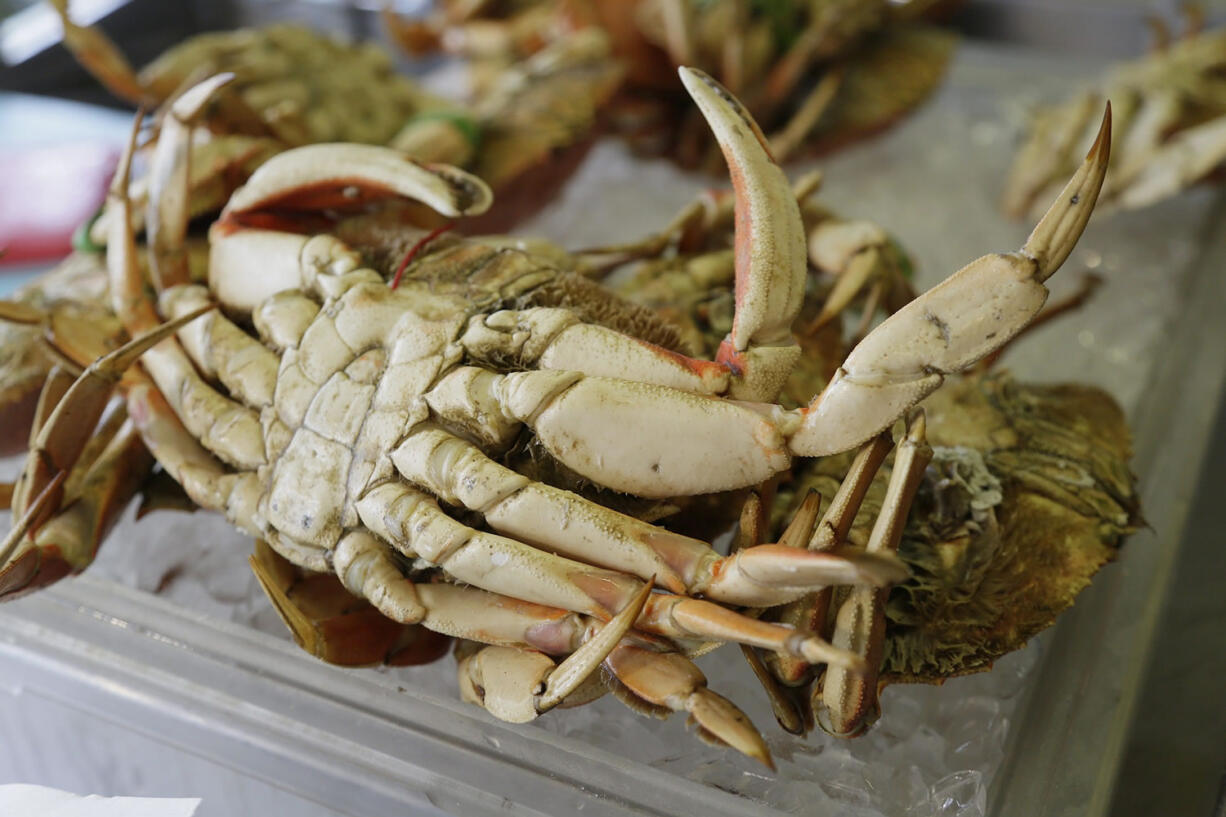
(0, 43, 1226, 817)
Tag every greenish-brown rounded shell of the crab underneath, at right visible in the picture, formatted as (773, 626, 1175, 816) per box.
(774, 374, 1138, 682)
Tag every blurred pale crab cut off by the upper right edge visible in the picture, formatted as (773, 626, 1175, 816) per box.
(1002, 9, 1226, 218)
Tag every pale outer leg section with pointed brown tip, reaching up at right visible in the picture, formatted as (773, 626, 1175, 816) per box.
(788, 105, 1111, 456)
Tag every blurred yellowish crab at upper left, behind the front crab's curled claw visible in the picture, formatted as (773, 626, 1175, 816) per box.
(53, 0, 620, 245)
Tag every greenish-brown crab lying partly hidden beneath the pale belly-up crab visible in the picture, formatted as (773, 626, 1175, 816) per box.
(605, 168, 1139, 737)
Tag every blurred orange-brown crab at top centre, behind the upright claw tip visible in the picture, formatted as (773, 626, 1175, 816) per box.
(385, 0, 954, 172)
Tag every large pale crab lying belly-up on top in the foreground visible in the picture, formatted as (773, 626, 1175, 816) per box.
(0, 69, 1110, 763)
